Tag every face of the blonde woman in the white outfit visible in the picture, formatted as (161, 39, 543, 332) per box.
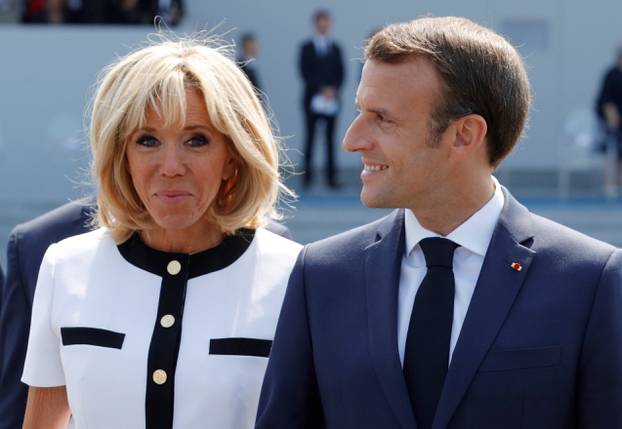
(127, 88, 235, 232)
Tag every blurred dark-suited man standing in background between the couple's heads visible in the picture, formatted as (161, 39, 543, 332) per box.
(299, 10, 344, 188)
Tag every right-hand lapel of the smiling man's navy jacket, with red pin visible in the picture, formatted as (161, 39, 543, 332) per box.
(432, 188, 535, 429)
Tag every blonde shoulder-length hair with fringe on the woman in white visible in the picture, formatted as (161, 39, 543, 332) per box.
(90, 38, 293, 242)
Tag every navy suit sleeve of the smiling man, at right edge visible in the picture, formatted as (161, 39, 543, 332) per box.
(577, 250, 622, 429)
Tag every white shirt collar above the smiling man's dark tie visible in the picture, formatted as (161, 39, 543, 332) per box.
(404, 176, 504, 256)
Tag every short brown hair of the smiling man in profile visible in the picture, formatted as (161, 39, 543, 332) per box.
(365, 17, 531, 167)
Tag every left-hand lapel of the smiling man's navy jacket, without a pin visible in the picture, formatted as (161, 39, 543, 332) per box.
(365, 210, 416, 429)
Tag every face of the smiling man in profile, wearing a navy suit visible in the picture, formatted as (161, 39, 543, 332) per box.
(343, 57, 451, 210)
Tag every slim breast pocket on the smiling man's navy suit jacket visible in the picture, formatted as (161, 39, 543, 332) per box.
(479, 346, 561, 372)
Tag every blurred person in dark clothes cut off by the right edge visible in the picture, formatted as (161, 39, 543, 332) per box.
(596, 45, 622, 197)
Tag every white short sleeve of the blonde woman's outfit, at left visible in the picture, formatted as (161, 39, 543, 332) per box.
(22, 245, 65, 387)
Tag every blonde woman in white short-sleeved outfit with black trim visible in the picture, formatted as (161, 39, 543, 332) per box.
(23, 40, 300, 429)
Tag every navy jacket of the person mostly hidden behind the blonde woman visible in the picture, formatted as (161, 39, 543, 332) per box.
(0, 200, 90, 429)
